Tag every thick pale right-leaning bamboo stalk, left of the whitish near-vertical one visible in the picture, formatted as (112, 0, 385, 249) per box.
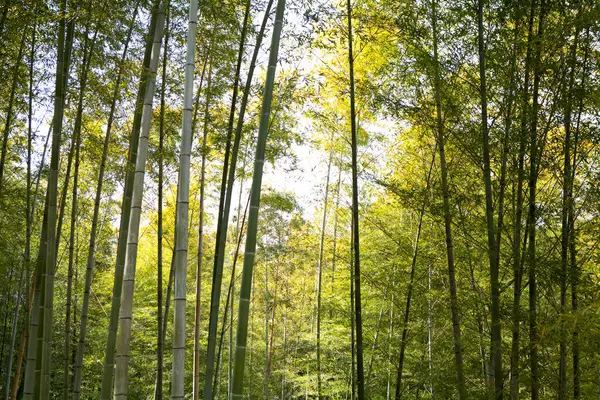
(114, 2, 165, 400)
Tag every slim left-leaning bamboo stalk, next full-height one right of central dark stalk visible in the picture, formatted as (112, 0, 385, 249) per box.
(431, 0, 467, 400)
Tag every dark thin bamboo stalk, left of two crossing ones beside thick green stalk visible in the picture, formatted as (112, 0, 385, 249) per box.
(203, 0, 251, 394)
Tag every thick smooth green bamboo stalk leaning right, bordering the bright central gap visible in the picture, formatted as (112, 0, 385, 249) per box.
(231, 0, 285, 400)
